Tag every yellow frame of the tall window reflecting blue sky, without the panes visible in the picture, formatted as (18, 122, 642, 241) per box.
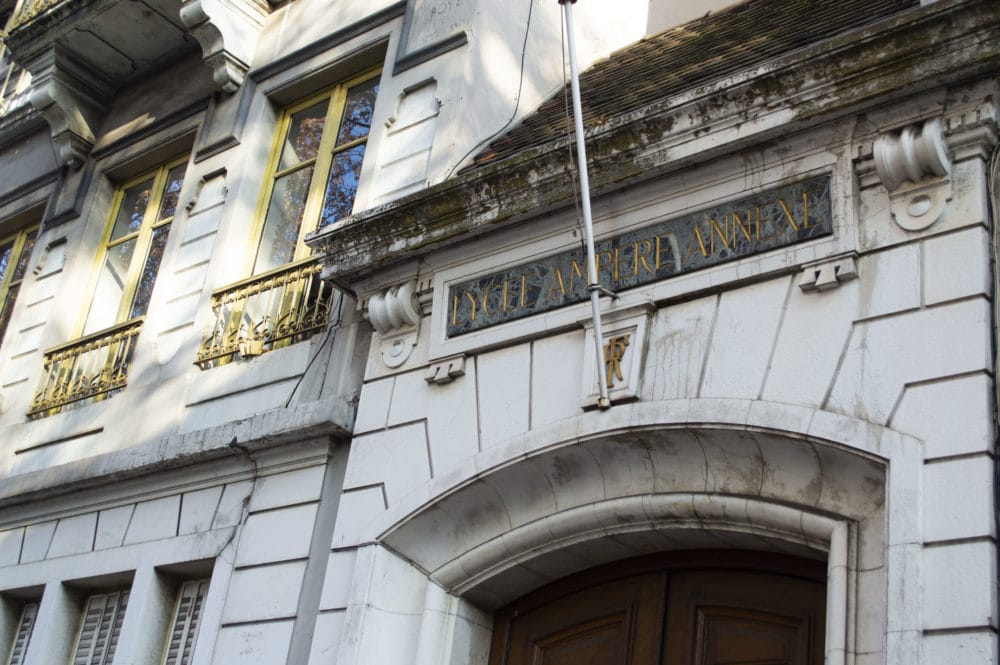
(247, 67, 382, 274)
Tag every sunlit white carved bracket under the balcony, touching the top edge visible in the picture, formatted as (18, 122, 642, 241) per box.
(181, 0, 270, 92)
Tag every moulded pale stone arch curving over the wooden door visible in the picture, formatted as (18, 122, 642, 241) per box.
(379, 400, 921, 663)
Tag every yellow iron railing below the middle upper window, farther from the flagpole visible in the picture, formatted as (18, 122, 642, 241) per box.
(28, 317, 143, 417)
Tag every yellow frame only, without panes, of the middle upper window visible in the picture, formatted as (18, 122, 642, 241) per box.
(75, 155, 188, 337)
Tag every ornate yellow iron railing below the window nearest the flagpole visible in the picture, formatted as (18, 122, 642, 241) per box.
(195, 259, 334, 369)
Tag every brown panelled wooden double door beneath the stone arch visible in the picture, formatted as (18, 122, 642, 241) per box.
(490, 552, 826, 665)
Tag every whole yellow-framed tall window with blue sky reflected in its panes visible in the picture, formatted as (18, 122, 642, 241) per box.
(253, 73, 378, 275)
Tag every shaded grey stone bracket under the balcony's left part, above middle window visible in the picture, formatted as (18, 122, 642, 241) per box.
(25, 46, 112, 169)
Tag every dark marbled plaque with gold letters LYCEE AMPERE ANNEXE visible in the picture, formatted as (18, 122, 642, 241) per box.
(447, 176, 833, 337)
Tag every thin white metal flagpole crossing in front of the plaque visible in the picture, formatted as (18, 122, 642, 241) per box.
(559, 0, 611, 409)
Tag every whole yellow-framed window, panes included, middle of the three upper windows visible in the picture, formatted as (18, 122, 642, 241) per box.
(83, 159, 187, 335)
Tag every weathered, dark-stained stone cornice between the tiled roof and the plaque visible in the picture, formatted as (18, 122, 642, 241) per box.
(307, 0, 1000, 288)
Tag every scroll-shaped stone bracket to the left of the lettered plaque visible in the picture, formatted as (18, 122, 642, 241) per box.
(361, 280, 422, 368)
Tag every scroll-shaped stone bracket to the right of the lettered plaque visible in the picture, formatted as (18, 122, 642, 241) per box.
(873, 118, 952, 231)
